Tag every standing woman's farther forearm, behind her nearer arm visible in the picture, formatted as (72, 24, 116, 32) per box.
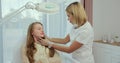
(49, 34, 70, 44)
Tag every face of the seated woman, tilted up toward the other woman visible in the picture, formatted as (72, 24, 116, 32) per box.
(32, 24, 44, 37)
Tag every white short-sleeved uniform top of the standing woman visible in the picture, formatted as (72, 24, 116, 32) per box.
(70, 22, 94, 63)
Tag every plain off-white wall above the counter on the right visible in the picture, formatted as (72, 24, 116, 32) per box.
(93, 0, 120, 40)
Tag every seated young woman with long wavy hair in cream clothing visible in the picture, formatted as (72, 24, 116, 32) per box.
(22, 22, 61, 63)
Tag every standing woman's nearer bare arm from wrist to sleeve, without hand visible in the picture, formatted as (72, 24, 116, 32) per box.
(51, 41, 83, 53)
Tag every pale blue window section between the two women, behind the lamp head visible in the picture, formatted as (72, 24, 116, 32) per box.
(46, 0, 67, 37)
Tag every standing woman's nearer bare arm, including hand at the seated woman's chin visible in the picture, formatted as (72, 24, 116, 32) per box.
(40, 39, 83, 53)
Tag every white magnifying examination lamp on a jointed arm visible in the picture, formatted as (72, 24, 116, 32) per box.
(0, 2, 59, 25)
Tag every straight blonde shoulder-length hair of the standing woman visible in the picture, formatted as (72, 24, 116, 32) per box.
(66, 2, 87, 27)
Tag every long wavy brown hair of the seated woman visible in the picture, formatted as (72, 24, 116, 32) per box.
(26, 22, 55, 63)
